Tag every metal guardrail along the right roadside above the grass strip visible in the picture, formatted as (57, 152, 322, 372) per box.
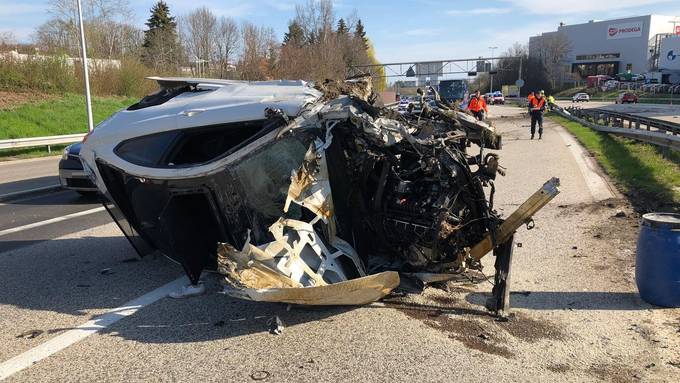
(554, 107, 680, 151)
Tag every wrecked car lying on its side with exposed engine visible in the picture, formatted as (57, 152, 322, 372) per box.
(81, 77, 559, 313)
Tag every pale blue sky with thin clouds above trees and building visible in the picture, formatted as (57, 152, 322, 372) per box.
(0, 0, 680, 63)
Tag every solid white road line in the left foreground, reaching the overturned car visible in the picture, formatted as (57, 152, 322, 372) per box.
(0, 276, 188, 380)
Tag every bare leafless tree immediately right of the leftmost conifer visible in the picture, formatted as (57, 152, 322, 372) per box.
(179, 7, 217, 75)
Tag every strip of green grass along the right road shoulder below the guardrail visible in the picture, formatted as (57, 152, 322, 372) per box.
(548, 113, 680, 211)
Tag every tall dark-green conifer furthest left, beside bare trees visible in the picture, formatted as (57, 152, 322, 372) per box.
(142, 0, 180, 70)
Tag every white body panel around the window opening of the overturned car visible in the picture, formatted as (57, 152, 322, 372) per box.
(80, 77, 321, 193)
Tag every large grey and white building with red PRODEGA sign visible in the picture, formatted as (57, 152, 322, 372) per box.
(529, 15, 680, 82)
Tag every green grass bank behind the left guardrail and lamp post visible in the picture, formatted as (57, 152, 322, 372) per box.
(0, 94, 136, 140)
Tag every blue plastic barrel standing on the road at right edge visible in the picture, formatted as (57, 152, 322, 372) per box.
(635, 213, 680, 307)
